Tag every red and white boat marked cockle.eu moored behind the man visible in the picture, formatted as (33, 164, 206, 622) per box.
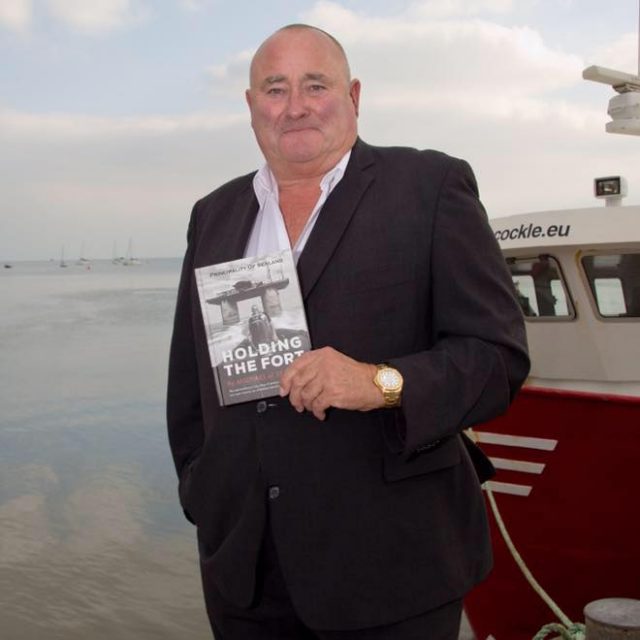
(465, 191, 640, 640)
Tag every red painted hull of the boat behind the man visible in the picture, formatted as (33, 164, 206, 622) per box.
(465, 388, 640, 640)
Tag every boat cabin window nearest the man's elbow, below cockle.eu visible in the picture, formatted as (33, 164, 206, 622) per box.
(507, 255, 575, 319)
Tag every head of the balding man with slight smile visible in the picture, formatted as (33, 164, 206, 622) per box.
(246, 29, 360, 178)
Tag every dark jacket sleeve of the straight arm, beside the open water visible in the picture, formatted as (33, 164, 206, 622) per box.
(167, 205, 204, 522)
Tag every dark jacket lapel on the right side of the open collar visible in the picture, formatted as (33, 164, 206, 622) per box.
(298, 140, 374, 299)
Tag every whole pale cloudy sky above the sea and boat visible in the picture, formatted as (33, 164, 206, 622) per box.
(0, 0, 640, 261)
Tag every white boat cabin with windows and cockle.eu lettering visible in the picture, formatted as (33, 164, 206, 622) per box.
(490, 206, 640, 397)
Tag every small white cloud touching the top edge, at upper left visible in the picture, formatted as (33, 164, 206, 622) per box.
(47, 0, 146, 33)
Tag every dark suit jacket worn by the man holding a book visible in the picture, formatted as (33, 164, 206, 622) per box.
(168, 141, 529, 629)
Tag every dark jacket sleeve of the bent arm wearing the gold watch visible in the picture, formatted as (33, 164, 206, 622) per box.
(390, 160, 529, 456)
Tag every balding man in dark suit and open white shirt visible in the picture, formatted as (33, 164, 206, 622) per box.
(168, 25, 529, 640)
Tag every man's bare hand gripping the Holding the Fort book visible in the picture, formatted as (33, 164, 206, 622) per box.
(280, 347, 384, 420)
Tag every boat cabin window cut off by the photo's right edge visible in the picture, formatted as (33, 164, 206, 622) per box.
(582, 253, 640, 318)
